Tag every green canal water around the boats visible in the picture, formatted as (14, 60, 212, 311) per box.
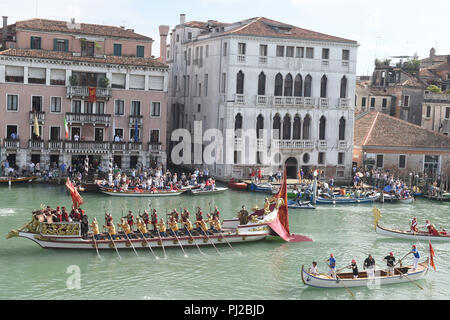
(0, 184, 450, 300)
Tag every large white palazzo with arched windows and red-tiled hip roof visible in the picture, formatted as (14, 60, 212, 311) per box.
(167, 15, 358, 179)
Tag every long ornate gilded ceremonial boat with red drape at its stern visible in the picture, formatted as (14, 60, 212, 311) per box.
(7, 172, 312, 250)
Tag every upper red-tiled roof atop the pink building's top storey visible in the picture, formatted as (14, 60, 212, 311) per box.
(16, 19, 152, 41)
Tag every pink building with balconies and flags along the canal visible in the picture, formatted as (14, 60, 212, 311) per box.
(0, 17, 169, 168)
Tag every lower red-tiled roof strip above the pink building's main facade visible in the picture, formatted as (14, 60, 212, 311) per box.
(0, 49, 168, 68)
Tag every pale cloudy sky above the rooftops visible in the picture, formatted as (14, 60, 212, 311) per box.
(0, 0, 450, 75)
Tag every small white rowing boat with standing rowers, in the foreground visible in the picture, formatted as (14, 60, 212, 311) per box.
(301, 259, 429, 288)
